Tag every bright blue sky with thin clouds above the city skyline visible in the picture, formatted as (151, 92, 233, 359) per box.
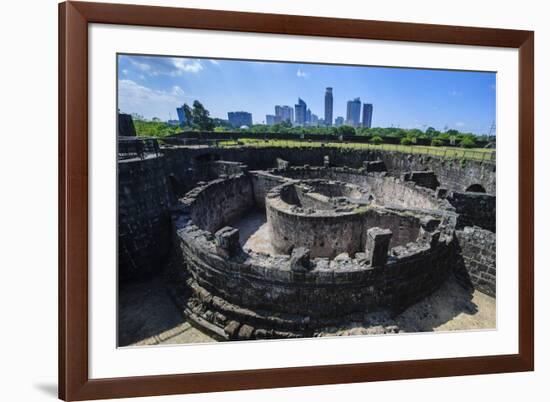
(118, 55, 496, 134)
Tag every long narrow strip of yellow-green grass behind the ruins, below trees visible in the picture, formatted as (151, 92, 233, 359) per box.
(218, 138, 495, 161)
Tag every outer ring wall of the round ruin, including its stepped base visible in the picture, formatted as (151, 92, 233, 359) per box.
(174, 176, 460, 339)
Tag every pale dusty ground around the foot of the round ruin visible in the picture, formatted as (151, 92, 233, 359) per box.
(118, 272, 496, 346)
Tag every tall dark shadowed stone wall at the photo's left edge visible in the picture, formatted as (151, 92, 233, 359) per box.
(118, 156, 172, 281)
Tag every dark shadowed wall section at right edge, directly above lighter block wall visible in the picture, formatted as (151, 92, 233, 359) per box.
(447, 191, 496, 232)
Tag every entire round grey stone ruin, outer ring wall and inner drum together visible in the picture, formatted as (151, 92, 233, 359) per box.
(173, 167, 462, 339)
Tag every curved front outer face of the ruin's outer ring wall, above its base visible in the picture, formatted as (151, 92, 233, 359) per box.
(176, 210, 458, 334)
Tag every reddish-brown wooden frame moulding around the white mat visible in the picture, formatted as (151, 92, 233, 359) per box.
(59, 1, 534, 401)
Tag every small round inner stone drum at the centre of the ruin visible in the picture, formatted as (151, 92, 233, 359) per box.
(265, 179, 372, 258)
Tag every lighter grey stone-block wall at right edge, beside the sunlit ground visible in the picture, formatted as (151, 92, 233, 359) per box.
(455, 227, 496, 297)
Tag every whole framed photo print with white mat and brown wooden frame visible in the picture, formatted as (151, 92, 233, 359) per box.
(59, 2, 534, 400)
